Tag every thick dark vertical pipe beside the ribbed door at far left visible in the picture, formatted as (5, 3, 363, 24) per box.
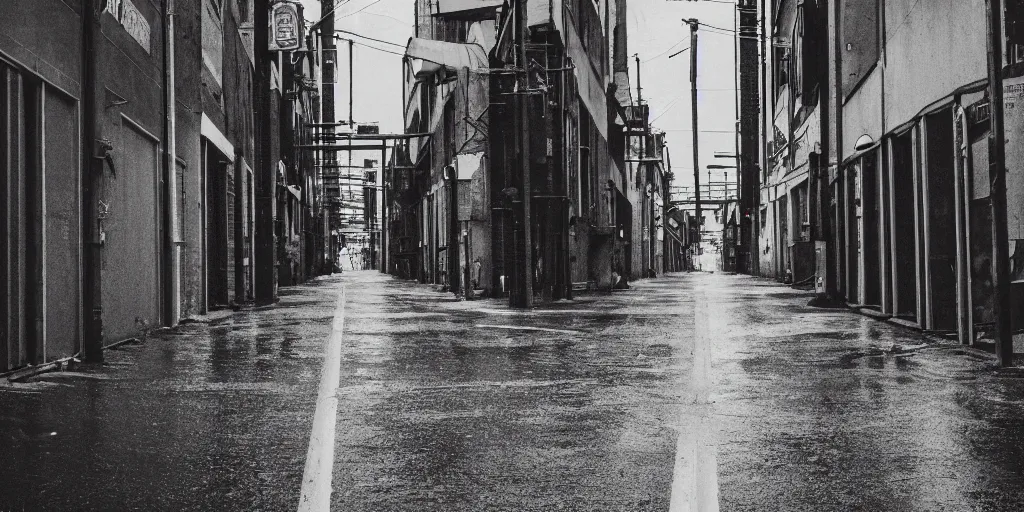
(82, 0, 105, 362)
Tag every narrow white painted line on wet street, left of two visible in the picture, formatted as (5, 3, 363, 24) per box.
(299, 285, 345, 512)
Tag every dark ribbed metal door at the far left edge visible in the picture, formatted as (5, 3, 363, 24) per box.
(0, 61, 82, 371)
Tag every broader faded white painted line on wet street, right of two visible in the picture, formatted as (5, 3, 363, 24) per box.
(669, 292, 719, 512)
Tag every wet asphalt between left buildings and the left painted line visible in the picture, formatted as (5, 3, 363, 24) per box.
(0, 276, 340, 510)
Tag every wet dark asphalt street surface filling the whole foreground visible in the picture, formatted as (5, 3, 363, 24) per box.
(0, 271, 1024, 511)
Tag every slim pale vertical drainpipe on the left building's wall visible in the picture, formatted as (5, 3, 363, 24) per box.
(164, 0, 182, 327)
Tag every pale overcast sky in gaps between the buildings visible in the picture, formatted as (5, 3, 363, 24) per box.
(302, 0, 736, 185)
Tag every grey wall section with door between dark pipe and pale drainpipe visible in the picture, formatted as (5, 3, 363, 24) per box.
(97, 1, 168, 342)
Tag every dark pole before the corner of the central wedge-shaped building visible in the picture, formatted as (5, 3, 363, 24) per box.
(511, 0, 534, 307)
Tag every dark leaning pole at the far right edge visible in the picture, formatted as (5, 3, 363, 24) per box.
(985, 0, 1014, 367)
